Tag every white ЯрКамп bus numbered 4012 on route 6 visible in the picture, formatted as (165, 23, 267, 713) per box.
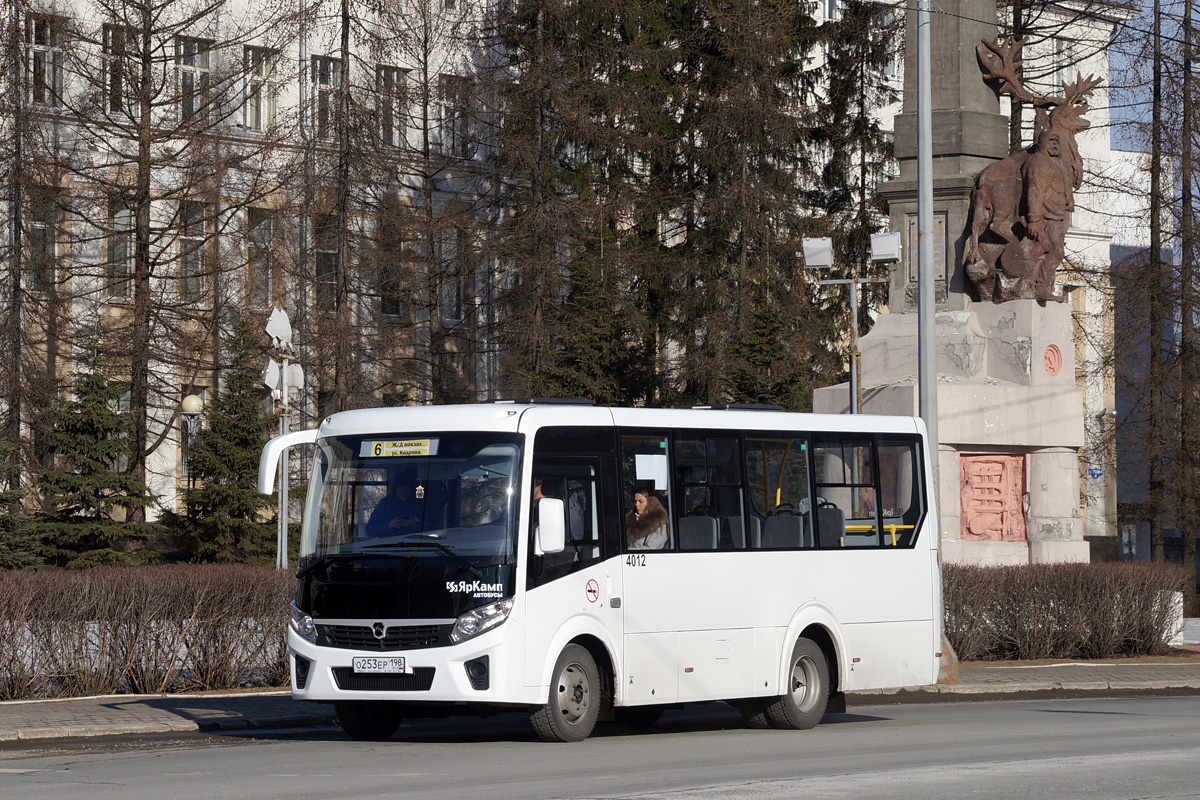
(259, 399, 941, 741)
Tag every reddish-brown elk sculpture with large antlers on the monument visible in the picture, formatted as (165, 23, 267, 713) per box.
(964, 38, 1100, 302)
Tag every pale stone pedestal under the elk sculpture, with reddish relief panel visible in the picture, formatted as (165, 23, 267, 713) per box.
(814, 300, 1090, 564)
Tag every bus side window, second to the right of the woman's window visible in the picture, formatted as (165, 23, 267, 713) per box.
(745, 433, 815, 549)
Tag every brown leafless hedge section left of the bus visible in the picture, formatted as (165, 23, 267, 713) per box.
(0, 565, 295, 699)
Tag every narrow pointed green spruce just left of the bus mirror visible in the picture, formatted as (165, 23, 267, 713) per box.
(163, 320, 275, 564)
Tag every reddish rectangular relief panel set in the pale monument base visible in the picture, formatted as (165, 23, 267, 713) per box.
(959, 456, 1025, 542)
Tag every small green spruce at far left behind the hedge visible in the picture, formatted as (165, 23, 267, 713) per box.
(29, 365, 154, 567)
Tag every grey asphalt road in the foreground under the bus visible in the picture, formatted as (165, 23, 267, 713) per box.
(0, 697, 1200, 800)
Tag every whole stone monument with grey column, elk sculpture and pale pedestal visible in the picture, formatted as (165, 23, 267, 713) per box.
(814, 0, 1096, 564)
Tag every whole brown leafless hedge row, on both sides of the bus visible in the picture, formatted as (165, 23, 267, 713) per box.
(0, 564, 1184, 699)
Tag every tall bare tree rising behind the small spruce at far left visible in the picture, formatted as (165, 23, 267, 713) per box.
(4, 0, 304, 525)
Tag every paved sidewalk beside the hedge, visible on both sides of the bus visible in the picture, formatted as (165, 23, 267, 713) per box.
(0, 619, 1200, 746)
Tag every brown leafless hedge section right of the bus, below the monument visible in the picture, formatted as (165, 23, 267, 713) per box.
(942, 564, 1186, 661)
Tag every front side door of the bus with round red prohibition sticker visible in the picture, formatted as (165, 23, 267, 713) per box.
(526, 456, 622, 686)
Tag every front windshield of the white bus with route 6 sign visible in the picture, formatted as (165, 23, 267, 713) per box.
(300, 432, 521, 569)
